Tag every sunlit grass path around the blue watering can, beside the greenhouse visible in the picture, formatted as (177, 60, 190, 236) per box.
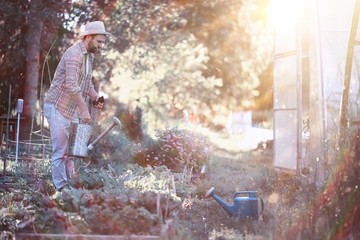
(173, 125, 324, 239)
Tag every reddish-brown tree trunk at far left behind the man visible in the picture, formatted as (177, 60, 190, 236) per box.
(22, 0, 44, 134)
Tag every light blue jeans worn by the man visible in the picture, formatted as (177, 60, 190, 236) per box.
(44, 102, 78, 190)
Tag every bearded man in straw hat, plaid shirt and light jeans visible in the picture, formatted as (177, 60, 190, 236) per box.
(44, 21, 112, 191)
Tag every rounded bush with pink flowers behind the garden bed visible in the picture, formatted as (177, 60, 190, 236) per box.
(134, 128, 209, 172)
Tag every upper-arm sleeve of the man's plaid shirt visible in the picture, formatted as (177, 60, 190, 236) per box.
(65, 52, 83, 96)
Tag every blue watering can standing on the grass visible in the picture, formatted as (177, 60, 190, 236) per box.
(205, 187, 264, 219)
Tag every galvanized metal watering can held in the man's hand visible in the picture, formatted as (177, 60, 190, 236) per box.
(69, 117, 121, 158)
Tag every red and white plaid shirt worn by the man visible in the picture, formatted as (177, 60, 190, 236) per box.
(45, 41, 94, 119)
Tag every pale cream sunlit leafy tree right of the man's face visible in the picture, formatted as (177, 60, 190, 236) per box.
(104, 33, 222, 129)
